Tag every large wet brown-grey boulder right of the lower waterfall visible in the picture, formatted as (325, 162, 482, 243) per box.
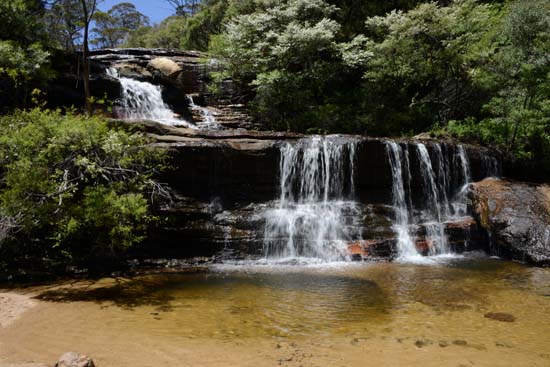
(469, 179, 550, 265)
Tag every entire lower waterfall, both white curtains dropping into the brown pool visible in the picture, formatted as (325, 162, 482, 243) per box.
(262, 136, 484, 261)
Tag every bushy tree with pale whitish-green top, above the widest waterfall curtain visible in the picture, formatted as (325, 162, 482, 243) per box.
(217, 0, 340, 129)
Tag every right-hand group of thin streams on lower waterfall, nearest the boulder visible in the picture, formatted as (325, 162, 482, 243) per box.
(386, 141, 470, 259)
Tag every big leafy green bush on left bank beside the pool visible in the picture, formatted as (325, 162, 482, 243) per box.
(0, 109, 167, 268)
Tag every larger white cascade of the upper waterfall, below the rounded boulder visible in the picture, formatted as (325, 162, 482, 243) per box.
(107, 68, 195, 128)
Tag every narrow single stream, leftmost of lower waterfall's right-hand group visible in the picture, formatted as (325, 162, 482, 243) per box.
(386, 141, 418, 258)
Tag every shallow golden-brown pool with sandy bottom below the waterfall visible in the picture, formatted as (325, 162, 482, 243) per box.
(0, 259, 550, 367)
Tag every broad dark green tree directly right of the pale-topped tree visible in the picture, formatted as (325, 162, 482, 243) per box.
(356, 0, 496, 134)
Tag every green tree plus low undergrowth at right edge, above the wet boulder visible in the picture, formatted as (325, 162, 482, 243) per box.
(448, 0, 550, 177)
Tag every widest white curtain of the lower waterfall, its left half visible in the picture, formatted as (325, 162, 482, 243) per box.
(264, 136, 361, 260)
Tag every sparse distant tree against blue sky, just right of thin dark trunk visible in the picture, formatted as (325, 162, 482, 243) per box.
(92, 3, 149, 47)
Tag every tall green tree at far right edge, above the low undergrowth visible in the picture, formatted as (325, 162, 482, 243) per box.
(487, 0, 550, 151)
